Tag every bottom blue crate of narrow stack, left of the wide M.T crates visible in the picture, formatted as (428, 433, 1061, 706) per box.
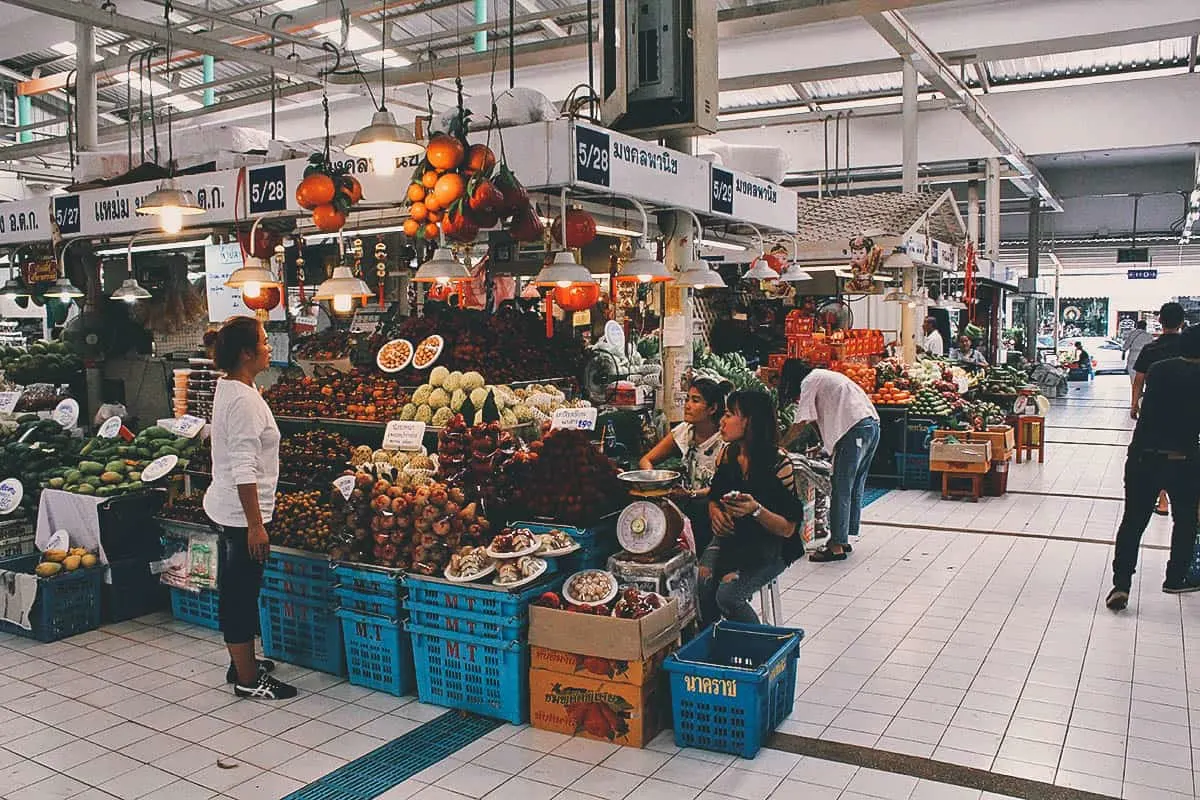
(337, 608, 416, 697)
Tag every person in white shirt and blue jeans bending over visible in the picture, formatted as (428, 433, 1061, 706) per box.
(779, 359, 880, 561)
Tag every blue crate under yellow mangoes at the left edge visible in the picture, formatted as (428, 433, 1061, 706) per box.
(0, 554, 104, 642)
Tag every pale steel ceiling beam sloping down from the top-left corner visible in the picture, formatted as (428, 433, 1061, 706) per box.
(4, 0, 320, 79)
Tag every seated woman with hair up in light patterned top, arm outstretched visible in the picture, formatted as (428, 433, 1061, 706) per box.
(637, 378, 733, 554)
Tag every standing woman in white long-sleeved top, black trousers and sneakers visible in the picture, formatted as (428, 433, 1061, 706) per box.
(204, 317, 296, 700)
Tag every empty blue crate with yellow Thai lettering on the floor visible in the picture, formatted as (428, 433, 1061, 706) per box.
(662, 620, 804, 758)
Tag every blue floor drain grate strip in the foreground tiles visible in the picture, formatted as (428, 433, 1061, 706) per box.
(284, 711, 504, 800)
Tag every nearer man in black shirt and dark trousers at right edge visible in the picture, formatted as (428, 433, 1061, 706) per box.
(1104, 327, 1200, 610)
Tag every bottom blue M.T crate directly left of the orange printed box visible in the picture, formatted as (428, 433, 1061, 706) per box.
(406, 622, 529, 724)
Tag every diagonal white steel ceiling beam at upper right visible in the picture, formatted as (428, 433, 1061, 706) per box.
(864, 11, 1063, 211)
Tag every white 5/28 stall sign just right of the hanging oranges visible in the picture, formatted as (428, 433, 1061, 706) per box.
(572, 122, 710, 215)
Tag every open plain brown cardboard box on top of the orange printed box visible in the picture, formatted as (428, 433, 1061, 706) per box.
(529, 600, 679, 661)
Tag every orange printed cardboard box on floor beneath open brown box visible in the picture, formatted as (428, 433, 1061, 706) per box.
(529, 666, 670, 747)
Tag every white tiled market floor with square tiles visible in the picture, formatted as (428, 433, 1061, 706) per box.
(0, 378, 1185, 800)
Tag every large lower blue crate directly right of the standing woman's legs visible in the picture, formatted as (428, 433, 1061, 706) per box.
(258, 588, 346, 676)
